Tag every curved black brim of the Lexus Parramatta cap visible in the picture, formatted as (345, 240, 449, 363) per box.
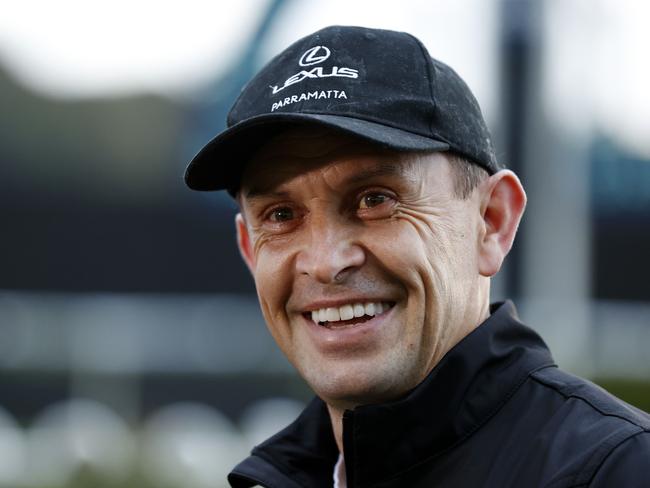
(185, 113, 449, 193)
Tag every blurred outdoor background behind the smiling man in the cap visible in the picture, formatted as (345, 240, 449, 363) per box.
(0, 0, 650, 488)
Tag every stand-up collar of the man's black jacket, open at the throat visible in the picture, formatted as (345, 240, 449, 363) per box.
(228, 301, 553, 486)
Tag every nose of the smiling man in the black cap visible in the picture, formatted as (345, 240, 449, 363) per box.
(296, 219, 366, 284)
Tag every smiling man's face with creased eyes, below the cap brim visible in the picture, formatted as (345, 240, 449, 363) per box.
(238, 131, 487, 408)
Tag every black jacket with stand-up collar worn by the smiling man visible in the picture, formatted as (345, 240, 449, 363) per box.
(229, 302, 650, 488)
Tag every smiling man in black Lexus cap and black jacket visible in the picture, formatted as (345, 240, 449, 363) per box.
(186, 27, 650, 488)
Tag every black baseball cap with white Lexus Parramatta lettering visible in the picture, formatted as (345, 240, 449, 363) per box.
(185, 26, 499, 194)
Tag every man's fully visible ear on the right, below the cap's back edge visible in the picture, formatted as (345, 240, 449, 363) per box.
(478, 170, 526, 276)
